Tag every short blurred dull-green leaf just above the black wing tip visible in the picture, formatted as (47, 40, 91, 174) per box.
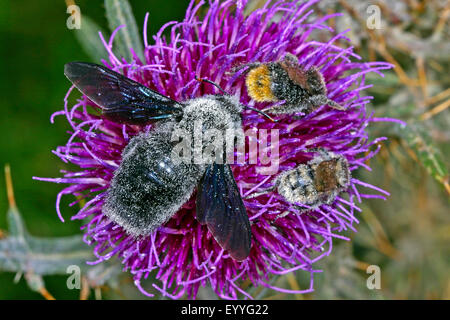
(74, 16, 108, 62)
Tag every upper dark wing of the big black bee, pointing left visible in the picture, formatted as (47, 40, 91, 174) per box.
(64, 62, 182, 124)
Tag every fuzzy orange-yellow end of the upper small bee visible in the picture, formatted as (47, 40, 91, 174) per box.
(245, 64, 277, 102)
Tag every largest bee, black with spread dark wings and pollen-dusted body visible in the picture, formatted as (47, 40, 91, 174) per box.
(64, 62, 255, 261)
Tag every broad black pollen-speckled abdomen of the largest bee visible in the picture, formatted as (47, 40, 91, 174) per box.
(102, 131, 200, 236)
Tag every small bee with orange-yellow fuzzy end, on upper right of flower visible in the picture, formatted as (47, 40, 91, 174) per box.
(244, 54, 345, 114)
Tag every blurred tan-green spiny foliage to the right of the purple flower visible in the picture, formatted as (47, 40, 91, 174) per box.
(312, 0, 450, 299)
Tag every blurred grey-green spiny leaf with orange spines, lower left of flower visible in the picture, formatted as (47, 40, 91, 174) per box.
(0, 165, 130, 299)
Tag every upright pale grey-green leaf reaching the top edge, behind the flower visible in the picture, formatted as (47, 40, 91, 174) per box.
(105, 0, 144, 61)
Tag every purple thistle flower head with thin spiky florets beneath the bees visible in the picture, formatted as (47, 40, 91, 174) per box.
(37, 0, 400, 299)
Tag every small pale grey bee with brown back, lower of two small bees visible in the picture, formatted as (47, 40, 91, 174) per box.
(247, 149, 351, 212)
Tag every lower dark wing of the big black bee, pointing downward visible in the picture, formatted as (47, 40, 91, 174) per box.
(197, 163, 252, 261)
